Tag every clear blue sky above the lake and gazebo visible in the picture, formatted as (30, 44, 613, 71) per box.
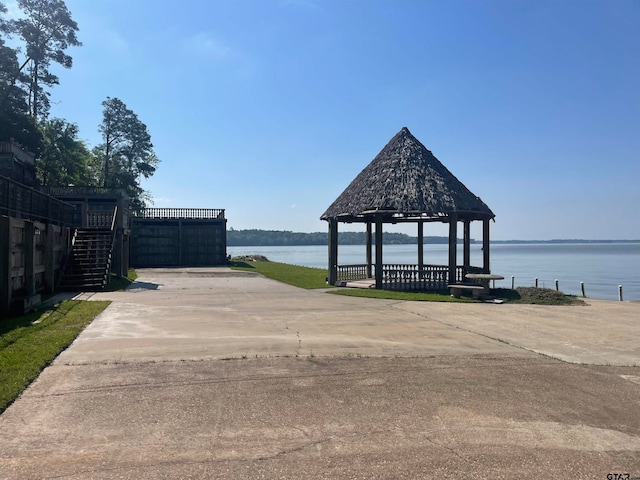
(5, 0, 640, 239)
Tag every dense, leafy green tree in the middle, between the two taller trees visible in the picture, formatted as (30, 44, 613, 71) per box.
(36, 118, 96, 186)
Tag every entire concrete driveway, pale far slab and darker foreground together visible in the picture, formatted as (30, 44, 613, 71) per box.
(0, 269, 640, 479)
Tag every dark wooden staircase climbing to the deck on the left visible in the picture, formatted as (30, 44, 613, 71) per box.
(59, 204, 117, 292)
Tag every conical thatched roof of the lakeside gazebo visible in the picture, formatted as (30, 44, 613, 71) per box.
(320, 127, 495, 222)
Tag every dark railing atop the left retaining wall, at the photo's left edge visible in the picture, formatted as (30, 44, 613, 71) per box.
(0, 177, 74, 225)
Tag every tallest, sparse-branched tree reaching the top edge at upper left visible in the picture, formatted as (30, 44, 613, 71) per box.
(2, 0, 81, 121)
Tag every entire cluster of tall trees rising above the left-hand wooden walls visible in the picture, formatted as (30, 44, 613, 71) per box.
(0, 0, 160, 208)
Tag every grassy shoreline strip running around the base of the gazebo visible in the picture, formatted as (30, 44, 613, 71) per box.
(229, 257, 584, 305)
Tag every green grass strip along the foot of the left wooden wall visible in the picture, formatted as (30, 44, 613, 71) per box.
(0, 300, 109, 413)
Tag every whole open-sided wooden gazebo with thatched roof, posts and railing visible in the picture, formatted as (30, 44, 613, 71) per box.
(320, 127, 495, 290)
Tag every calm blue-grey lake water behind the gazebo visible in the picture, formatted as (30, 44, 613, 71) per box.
(227, 243, 640, 301)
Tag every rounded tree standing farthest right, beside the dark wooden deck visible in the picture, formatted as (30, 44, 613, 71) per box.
(94, 97, 160, 208)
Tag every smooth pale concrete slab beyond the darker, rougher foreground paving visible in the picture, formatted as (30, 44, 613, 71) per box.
(58, 269, 640, 366)
